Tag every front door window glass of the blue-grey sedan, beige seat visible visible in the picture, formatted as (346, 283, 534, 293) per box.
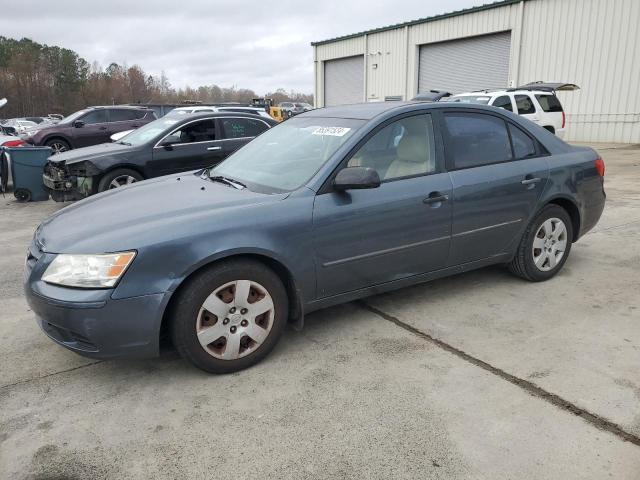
(347, 114, 436, 180)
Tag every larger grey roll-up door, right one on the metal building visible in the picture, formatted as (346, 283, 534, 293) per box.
(418, 32, 511, 93)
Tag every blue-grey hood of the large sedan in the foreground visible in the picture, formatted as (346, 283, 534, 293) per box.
(36, 172, 287, 253)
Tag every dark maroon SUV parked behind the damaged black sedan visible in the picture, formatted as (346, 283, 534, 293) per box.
(23, 105, 157, 154)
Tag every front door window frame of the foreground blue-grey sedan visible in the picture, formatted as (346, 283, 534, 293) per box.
(316, 108, 446, 195)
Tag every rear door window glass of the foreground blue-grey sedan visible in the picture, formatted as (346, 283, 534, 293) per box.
(444, 113, 512, 168)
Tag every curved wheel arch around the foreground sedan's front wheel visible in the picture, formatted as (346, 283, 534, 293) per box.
(159, 252, 304, 348)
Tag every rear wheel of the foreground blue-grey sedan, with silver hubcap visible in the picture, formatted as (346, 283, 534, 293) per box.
(509, 205, 573, 282)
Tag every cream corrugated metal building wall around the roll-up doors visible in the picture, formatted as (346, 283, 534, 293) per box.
(314, 0, 640, 142)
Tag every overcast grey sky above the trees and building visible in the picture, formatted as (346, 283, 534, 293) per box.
(0, 0, 480, 93)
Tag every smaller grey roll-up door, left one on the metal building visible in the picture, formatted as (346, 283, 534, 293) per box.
(324, 55, 364, 107)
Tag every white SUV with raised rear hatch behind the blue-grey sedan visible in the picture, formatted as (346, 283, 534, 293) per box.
(441, 82, 580, 138)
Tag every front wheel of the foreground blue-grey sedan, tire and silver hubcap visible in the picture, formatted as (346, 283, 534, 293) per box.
(169, 260, 289, 373)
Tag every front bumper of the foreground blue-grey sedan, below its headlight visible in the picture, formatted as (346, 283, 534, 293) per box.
(24, 238, 168, 358)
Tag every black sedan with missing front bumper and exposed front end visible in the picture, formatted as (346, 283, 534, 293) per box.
(43, 113, 278, 201)
